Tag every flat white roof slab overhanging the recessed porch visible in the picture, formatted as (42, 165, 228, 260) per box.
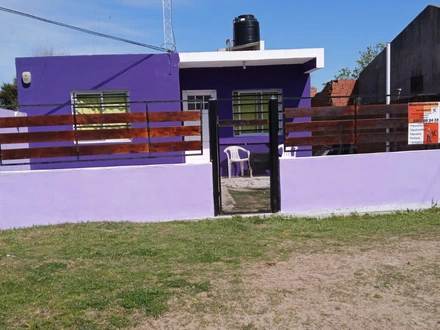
(179, 48, 324, 73)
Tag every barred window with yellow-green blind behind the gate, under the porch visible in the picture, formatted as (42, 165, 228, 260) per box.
(232, 90, 282, 135)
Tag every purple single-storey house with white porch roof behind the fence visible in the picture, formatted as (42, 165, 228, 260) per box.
(12, 41, 324, 175)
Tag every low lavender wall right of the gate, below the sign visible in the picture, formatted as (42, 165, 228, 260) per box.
(280, 150, 440, 215)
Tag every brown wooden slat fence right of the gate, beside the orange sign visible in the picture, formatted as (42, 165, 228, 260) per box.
(285, 104, 425, 153)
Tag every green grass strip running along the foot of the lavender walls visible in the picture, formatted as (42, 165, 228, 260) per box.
(0, 208, 440, 329)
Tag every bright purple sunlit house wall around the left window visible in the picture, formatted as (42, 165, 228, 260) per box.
(16, 54, 183, 169)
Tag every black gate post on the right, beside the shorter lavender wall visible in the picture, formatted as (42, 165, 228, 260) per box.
(269, 96, 281, 213)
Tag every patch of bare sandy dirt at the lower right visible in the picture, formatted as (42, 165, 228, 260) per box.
(139, 238, 440, 330)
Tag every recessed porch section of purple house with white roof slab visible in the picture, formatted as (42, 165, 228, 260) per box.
(179, 49, 324, 175)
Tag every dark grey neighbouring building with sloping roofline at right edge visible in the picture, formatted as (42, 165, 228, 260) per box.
(358, 5, 440, 103)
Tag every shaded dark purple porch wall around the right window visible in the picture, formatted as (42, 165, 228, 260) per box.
(180, 65, 311, 176)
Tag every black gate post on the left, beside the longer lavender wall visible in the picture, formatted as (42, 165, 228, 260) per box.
(208, 99, 221, 216)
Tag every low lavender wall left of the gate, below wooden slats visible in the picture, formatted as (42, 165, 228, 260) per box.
(0, 164, 214, 229)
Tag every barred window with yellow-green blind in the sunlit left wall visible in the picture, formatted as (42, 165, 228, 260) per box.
(72, 91, 129, 130)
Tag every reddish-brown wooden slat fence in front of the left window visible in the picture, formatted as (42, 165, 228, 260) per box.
(0, 111, 202, 162)
